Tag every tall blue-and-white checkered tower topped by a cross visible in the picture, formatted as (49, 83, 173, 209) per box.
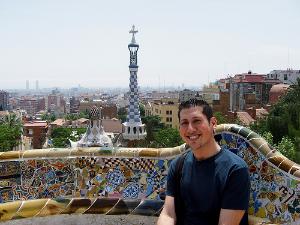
(123, 25, 147, 140)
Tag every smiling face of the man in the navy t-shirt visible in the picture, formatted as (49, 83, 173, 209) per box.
(179, 106, 217, 150)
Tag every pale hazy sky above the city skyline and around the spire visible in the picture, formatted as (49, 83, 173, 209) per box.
(0, 0, 300, 89)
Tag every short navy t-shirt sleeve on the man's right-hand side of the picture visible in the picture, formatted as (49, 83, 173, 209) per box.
(221, 167, 250, 210)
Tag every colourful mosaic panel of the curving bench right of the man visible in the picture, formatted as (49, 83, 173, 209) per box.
(217, 133, 300, 224)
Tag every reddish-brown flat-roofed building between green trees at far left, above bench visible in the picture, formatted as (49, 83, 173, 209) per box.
(23, 121, 48, 149)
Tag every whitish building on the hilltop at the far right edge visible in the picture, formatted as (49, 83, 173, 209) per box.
(267, 69, 300, 85)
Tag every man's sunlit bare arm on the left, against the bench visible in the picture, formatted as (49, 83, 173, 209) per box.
(157, 195, 176, 225)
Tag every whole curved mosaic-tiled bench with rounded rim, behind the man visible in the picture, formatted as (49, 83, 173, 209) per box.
(0, 124, 300, 224)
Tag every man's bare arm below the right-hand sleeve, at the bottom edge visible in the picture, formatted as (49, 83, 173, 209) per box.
(219, 209, 245, 225)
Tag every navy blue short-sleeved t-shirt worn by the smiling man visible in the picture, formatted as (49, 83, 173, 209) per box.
(166, 149, 250, 225)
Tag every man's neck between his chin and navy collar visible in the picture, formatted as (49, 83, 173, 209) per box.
(192, 140, 221, 160)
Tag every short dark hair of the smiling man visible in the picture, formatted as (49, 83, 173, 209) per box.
(178, 98, 213, 121)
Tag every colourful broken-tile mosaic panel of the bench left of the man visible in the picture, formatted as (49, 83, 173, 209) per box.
(0, 157, 170, 203)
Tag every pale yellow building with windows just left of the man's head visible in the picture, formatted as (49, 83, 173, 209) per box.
(145, 98, 179, 129)
